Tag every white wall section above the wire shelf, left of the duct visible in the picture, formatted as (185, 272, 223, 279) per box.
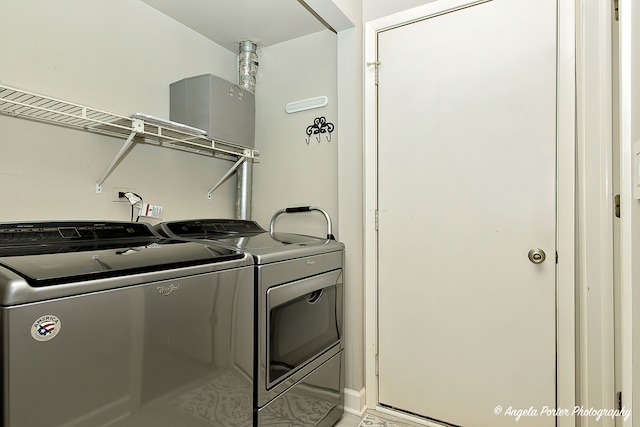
(0, 0, 237, 118)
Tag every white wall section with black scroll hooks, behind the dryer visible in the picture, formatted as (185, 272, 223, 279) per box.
(252, 30, 341, 236)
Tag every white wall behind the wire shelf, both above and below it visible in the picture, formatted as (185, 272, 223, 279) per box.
(0, 0, 237, 222)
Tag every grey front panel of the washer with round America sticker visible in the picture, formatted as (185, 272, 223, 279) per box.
(1, 267, 254, 427)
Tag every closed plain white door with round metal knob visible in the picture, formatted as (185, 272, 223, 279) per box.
(377, 0, 556, 427)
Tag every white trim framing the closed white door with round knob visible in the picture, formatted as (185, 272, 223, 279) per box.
(363, 0, 577, 427)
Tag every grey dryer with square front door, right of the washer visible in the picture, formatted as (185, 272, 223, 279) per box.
(156, 208, 344, 427)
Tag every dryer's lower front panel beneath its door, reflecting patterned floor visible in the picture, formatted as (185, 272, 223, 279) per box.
(257, 351, 344, 427)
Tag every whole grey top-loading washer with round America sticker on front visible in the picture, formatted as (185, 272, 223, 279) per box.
(0, 222, 254, 427)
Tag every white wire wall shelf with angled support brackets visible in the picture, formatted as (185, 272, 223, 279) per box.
(0, 85, 260, 196)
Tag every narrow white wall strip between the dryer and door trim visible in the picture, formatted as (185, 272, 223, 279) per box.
(330, 0, 450, 412)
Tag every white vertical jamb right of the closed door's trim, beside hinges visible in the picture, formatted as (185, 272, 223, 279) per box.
(576, 0, 624, 427)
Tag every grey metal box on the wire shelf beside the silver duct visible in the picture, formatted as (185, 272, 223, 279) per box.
(169, 74, 256, 148)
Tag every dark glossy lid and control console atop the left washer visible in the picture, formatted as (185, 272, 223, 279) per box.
(0, 223, 244, 287)
